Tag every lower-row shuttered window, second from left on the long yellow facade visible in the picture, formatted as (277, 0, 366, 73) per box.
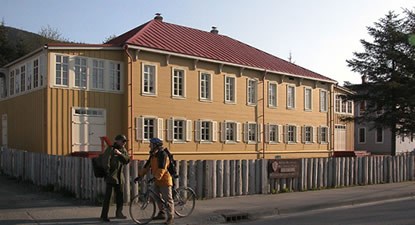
(167, 118, 192, 143)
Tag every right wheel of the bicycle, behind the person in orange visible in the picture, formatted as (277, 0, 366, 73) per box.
(173, 187, 196, 217)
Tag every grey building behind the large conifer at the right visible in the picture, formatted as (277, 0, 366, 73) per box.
(355, 101, 415, 155)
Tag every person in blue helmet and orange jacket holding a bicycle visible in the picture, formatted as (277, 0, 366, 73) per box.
(134, 138, 174, 224)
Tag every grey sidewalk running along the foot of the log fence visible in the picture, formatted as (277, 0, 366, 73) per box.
(0, 175, 415, 225)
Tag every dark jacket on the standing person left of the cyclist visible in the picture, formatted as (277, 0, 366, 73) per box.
(104, 146, 130, 184)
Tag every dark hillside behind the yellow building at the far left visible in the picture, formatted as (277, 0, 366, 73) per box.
(0, 26, 57, 67)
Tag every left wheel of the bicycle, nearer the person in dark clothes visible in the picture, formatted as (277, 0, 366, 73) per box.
(130, 194, 156, 224)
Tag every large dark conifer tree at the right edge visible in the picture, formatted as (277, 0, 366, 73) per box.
(346, 9, 415, 153)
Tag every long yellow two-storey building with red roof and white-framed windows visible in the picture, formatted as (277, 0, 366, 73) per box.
(0, 15, 354, 159)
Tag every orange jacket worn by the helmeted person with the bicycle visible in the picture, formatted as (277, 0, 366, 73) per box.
(138, 150, 173, 187)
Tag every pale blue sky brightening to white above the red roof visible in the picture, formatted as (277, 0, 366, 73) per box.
(0, 0, 415, 85)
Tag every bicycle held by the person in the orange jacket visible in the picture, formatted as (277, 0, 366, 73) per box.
(130, 178, 196, 224)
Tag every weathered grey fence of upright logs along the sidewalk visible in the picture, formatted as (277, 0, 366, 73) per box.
(0, 148, 415, 202)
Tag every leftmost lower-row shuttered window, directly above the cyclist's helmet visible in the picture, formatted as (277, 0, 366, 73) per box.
(136, 116, 163, 141)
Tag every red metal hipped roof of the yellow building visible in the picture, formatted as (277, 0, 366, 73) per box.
(106, 19, 334, 82)
